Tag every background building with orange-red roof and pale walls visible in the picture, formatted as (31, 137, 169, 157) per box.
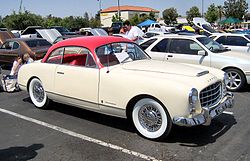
(101, 6, 160, 27)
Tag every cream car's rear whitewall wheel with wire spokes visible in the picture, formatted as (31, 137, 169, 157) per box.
(29, 78, 49, 109)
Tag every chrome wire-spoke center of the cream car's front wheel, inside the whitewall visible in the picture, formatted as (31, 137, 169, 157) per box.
(138, 105, 162, 132)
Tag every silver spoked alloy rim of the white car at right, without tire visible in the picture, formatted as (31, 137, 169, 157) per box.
(227, 71, 241, 89)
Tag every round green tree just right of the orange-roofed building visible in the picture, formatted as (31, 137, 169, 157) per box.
(162, 7, 178, 25)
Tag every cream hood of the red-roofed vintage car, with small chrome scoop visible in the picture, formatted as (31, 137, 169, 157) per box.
(123, 60, 209, 77)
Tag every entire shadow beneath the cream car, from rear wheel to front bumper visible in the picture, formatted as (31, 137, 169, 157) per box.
(23, 97, 237, 147)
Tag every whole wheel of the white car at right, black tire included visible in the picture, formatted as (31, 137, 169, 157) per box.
(225, 68, 246, 92)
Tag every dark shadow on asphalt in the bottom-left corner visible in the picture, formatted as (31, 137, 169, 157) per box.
(0, 144, 44, 161)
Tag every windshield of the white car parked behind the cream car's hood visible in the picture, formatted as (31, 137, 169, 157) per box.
(197, 37, 229, 53)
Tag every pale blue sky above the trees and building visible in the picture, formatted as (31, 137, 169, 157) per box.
(0, 0, 250, 17)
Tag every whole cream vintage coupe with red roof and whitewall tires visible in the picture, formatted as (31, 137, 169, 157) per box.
(18, 36, 234, 139)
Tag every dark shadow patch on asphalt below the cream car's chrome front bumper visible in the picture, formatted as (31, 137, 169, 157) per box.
(165, 113, 237, 147)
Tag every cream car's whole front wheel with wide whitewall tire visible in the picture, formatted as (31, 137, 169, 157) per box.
(132, 98, 172, 140)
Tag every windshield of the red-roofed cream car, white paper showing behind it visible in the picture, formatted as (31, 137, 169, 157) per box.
(96, 43, 149, 66)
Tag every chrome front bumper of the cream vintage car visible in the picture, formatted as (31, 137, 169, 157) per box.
(173, 92, 234, 126)
